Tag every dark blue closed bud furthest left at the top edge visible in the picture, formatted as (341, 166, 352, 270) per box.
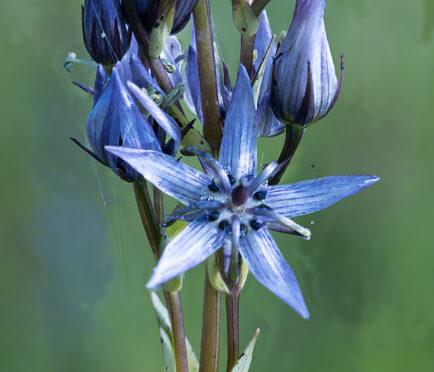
(82, 0, 130, 65)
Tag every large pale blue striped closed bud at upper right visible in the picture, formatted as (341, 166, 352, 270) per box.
(271, 0, 343, 127)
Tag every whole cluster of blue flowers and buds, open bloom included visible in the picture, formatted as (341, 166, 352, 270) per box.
(76, 0, 378, 318)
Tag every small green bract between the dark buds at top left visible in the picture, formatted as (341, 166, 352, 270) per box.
(148, 0, 176, 59)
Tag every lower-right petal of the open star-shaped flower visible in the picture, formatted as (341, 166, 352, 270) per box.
(239, 229, 309, 319)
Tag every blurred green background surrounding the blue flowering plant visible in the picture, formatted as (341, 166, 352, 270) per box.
(0, 0, 434, 372)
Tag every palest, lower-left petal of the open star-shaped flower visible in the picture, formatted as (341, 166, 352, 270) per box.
(146, 218, 225, 289)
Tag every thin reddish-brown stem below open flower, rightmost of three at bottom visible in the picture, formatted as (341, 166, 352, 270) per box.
(226, 287, 241, 372)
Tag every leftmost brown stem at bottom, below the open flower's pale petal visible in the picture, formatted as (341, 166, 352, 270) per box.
(164, 291, 188, 372)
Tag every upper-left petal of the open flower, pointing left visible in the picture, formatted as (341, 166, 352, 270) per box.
(106, 146, 211, 204)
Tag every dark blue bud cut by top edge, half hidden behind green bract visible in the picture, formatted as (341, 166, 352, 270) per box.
(131, 0, 198, 34)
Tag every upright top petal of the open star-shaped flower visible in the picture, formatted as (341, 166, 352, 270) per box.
(220, 65, 258, 178)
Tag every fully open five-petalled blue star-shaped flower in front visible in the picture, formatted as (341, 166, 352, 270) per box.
(106, 66, 378, 318)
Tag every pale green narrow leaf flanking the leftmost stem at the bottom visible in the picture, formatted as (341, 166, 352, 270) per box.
(150, 292, 199, 372)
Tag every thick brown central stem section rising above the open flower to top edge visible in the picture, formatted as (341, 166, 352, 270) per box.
(193, 0, 222, 152)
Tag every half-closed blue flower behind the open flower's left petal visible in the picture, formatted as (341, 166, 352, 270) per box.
(75, 57, 181, 181)
